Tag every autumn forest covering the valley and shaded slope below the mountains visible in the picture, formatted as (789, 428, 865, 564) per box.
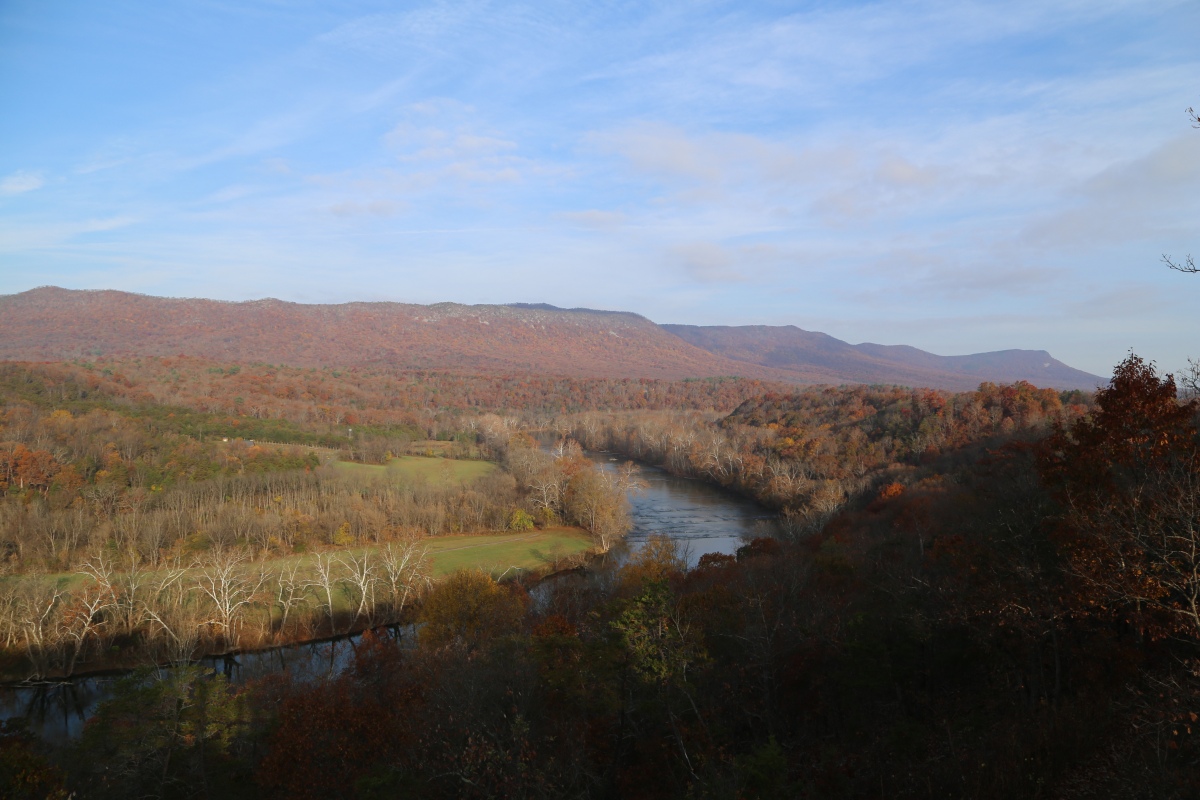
(0, 356, 1200, 799)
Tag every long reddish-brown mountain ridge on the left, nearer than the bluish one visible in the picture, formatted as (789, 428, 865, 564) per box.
(0, 287, 796, 381)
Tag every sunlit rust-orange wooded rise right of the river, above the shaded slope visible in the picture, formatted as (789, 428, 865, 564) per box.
(558, 381, 1091, 533)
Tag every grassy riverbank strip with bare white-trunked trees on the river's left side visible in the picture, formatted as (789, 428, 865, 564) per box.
(0, 527, 593, 684)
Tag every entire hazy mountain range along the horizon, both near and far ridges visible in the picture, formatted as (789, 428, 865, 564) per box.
(0, 287, 1105, 390)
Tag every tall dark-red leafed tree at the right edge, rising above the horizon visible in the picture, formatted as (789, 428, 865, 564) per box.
(1043, 355, 1200, 637)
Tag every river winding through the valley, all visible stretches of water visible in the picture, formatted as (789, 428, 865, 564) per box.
(0, 452, 775, 742)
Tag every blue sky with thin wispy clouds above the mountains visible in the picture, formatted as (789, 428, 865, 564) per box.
(0, 0, 1200, 375)
